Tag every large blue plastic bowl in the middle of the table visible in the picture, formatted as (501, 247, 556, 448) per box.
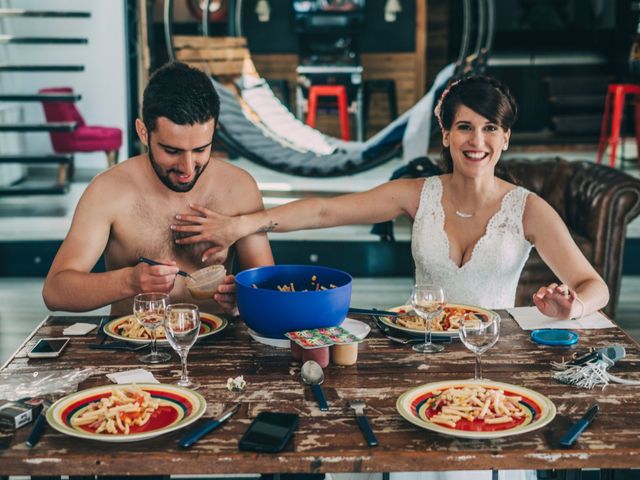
(236, 265, 352, 338)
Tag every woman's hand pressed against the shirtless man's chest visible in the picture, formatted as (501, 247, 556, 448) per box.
(171, 203, 240, 261)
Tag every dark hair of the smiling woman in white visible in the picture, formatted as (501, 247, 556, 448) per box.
(436, 75, 518, 172)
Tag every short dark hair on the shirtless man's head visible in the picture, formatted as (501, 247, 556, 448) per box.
(142, 62, 220, 132)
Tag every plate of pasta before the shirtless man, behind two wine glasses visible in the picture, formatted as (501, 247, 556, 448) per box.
(104, 312, 228, 343)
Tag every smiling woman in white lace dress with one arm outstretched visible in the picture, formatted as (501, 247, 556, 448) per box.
(171, 76, 609, 319)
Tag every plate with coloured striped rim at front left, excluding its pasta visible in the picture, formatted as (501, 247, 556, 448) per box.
(47, 384, 207, 443)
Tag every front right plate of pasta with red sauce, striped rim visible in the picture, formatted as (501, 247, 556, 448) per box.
(396, 380, 556, 439)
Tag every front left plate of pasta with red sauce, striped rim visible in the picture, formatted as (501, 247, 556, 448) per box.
(47, 384, 207, 443)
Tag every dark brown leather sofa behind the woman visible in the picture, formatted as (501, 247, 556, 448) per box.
(374, 157, 640, 318)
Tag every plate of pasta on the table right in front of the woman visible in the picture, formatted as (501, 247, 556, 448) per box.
(380, 303, 498, 337)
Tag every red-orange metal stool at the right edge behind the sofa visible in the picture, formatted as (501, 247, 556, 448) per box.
(596, 83, 640, 167)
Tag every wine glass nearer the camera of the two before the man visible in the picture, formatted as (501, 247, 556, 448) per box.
(164, 303, 200, 388)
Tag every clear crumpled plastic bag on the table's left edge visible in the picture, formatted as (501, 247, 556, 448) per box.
(0, 368, 95, 401)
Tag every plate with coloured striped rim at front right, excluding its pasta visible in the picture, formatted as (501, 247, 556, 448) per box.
(396, 380, 556, 439)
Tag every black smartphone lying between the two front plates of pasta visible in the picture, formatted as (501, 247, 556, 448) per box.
(238, 412, 298, 452)
